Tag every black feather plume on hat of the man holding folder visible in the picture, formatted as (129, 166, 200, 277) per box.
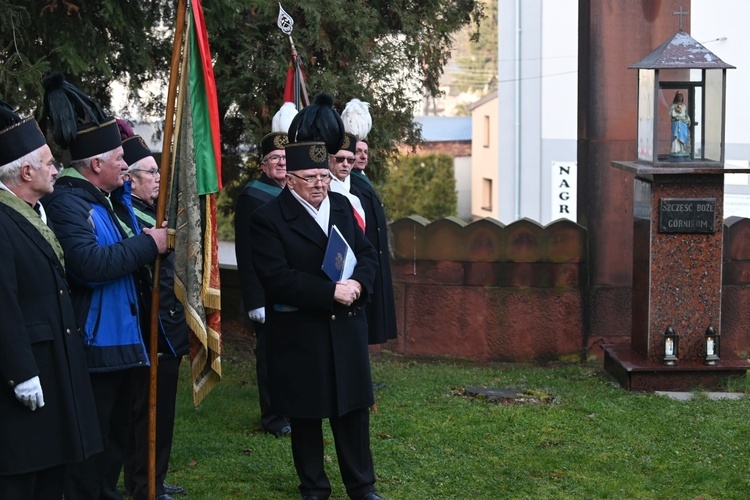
(287, 94, 345, 153)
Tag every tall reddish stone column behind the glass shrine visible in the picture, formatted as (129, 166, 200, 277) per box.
(578, 0, 690, 355)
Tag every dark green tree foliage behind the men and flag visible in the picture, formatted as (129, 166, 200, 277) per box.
(0, 0, 484, 223)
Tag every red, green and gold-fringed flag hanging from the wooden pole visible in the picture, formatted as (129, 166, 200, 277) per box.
(167, 0, 222, 405)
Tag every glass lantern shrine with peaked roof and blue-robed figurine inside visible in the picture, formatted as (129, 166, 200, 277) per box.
(630, 31, 734, 167)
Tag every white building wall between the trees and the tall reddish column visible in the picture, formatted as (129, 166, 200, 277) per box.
(497, 0, 578, 224)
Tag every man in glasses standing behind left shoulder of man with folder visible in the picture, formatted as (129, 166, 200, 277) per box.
(234, 127, 292, 437)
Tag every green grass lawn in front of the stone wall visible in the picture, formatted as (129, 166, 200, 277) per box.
(167, 346, 750, 500)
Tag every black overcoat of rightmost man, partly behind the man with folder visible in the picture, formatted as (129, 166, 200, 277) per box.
(350, 169, 398, 344)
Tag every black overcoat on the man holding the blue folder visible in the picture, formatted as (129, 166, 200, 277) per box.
(251, 187, 377, 418)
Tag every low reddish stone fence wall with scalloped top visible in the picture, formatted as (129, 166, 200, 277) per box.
(222, 217, 750, 362)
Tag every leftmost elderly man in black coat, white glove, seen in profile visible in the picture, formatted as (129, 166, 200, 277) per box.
(0, 102, 102, 499)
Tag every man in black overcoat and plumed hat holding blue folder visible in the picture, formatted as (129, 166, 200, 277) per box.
(251, 94, 381, 500)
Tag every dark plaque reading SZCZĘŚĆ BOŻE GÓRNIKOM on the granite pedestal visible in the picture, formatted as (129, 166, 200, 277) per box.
(659, 198, 716, 233)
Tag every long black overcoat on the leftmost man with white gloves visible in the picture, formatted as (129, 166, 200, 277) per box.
(0, 203, 102, 475)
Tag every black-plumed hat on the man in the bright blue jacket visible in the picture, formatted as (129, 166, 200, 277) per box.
(43, 72, 122, 160)
